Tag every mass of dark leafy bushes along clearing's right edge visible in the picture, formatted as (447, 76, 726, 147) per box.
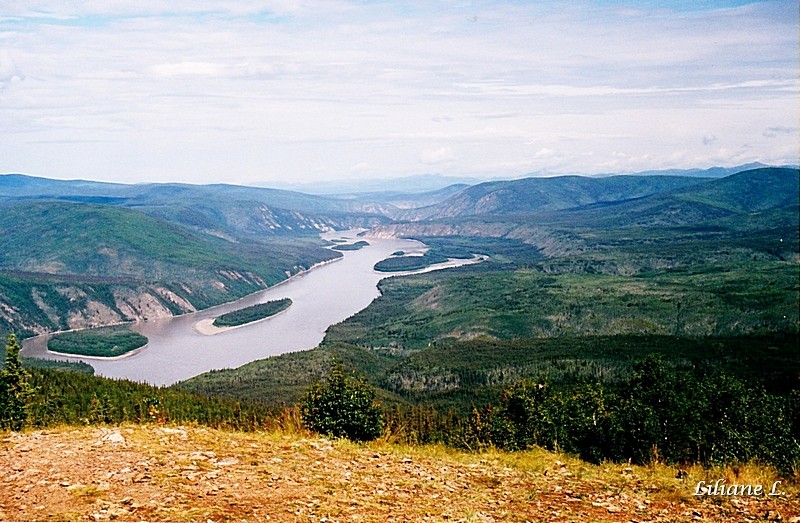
(472, 356, 800, 476)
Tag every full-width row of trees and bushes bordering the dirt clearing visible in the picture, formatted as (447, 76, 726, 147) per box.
(0, 335, 800, 476)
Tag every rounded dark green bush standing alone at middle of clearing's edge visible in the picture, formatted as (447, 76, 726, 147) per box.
(300, 364, 383, 441)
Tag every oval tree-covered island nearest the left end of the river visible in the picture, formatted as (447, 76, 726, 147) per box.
(47, 327, 147, 358)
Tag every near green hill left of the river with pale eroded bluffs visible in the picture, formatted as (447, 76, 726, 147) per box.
(0, 202, 339, 334)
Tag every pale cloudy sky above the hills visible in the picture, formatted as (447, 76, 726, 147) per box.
(0, 0, 800, 184)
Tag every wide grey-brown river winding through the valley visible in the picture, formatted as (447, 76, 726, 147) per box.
(22, 231, 476, 385)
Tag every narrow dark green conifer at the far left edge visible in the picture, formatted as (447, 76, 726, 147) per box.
(0, 334, 33, 430)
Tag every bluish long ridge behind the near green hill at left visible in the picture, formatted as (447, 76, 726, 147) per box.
(0, 174, 386, 240)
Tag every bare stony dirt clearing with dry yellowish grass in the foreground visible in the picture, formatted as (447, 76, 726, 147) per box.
(0, 425, 800, 523)
